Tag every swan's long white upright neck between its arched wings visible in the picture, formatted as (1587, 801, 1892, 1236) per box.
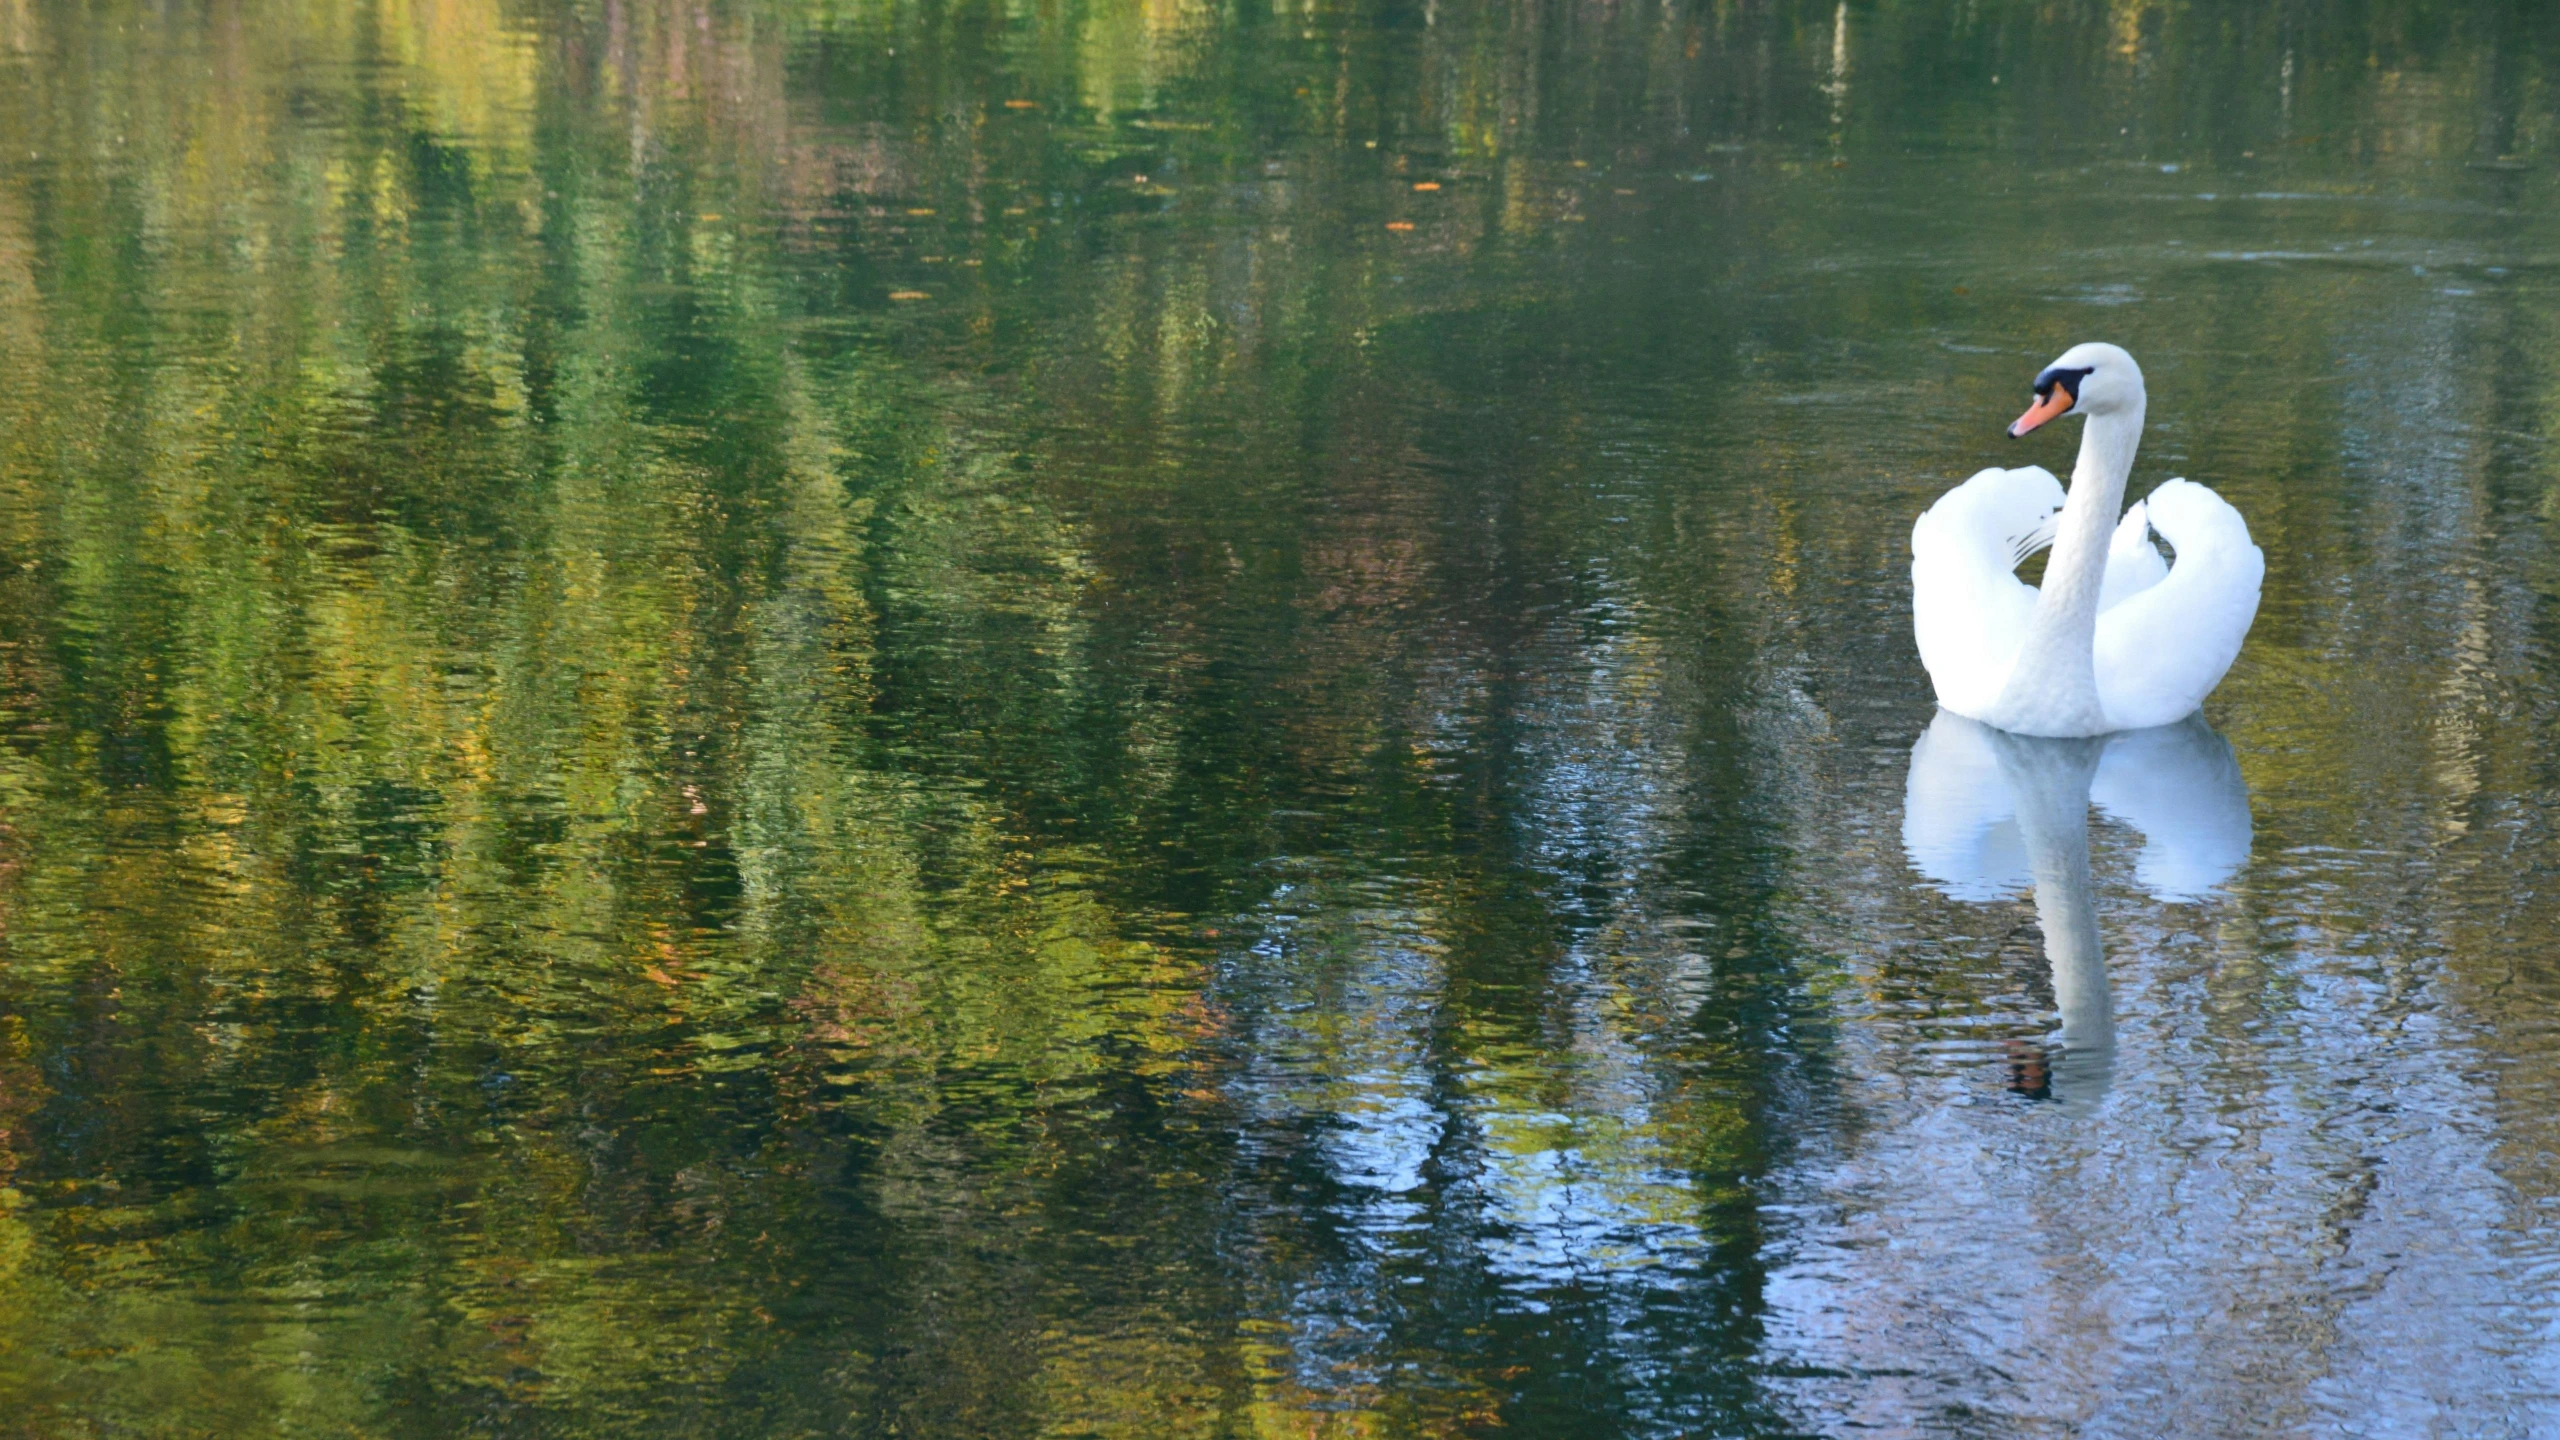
(1999, 395, 2143, 735)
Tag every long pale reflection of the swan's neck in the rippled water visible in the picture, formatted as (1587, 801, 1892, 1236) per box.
(1992, 730, 2115, 1086)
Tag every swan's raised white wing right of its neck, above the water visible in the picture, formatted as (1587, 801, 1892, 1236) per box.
(2097, 479, 2266, 730)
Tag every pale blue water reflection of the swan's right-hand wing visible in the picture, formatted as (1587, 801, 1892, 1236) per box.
(2089, 707, 2250, 899)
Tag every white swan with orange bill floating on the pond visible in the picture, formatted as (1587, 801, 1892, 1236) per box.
(1912, 343, 2266, 735)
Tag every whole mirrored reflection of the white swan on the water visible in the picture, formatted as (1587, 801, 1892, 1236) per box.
(1902, 710, 2250, 1102)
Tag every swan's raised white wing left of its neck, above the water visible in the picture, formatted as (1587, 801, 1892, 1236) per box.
(1912, 466, 2063, 715)
